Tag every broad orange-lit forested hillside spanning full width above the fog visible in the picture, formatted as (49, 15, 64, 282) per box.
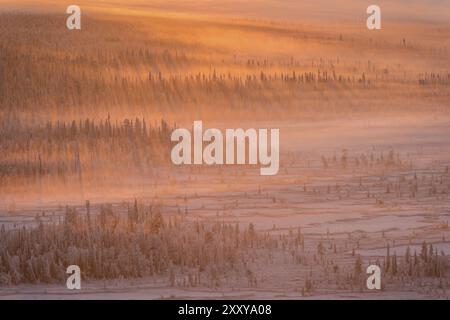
(0, 14, 448, 120)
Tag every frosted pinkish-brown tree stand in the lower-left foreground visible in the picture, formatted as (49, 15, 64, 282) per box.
(0, 202, 269, 285)
